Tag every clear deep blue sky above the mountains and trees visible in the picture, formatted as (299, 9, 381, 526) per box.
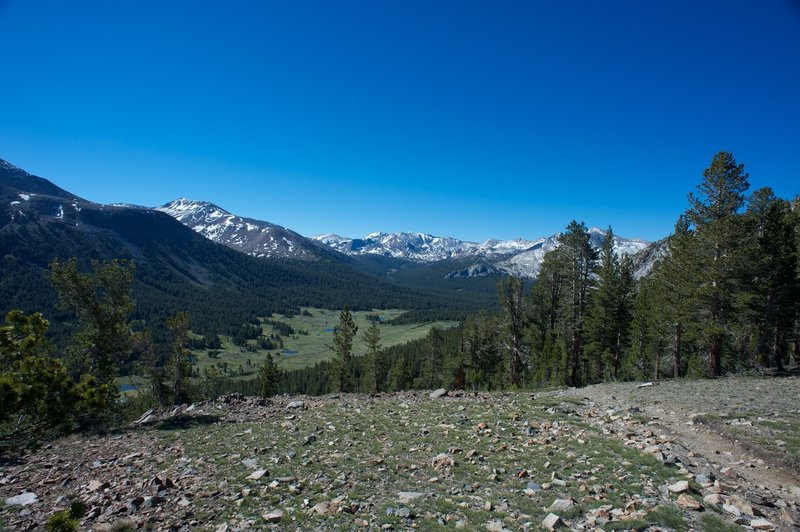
(0, 0, 800, 240)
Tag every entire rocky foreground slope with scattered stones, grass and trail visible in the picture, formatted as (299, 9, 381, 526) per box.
(0, 377, 800, 531)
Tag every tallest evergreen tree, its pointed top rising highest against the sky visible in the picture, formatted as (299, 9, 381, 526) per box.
(687, 151, 750, 377)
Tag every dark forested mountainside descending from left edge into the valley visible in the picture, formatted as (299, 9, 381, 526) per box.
(0, 160, 462, 340)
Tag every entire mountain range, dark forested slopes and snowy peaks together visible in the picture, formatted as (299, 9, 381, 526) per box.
(0, 159, 663, 338)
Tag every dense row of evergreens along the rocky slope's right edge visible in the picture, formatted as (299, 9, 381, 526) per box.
(231, 152, 800, 393)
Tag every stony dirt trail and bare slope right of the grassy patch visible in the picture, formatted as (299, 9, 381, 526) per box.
(556, 377, 800, 529)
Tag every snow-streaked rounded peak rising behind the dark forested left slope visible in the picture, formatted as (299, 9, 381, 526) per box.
(156, 198, 329, 260)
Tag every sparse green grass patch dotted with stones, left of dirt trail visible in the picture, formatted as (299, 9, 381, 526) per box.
(152, 395, 688, 530)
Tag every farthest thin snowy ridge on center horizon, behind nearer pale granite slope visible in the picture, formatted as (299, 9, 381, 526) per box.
(311, 233, 536, 262)
